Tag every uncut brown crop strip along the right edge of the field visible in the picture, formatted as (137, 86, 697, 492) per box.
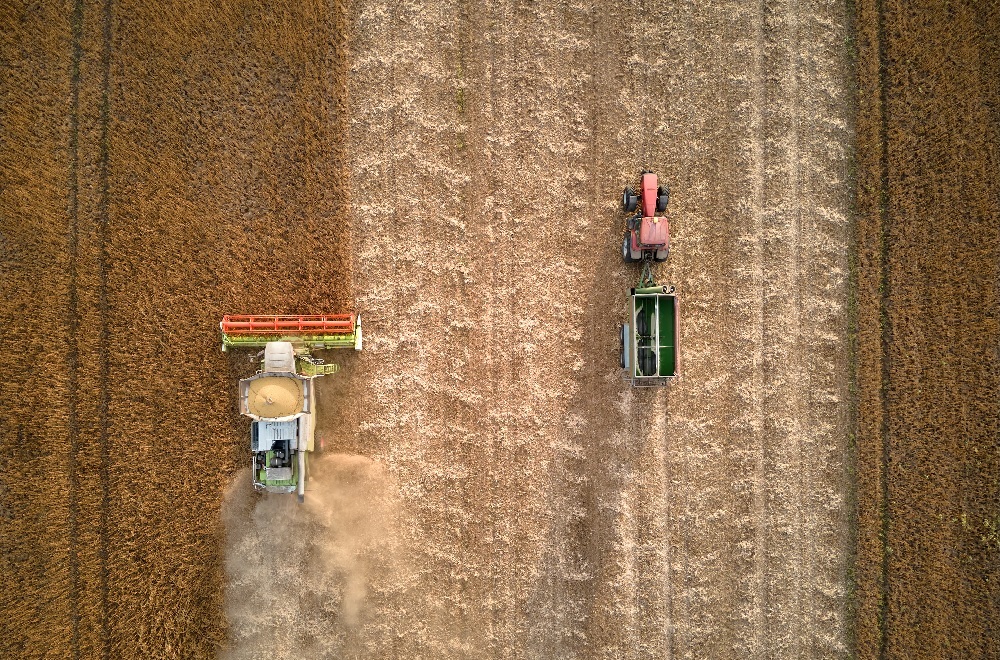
(856, 1, 1000, 658)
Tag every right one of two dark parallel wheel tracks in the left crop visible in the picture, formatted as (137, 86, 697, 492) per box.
(97, 0, 111, 660)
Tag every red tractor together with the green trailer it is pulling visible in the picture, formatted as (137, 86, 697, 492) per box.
(621, 171, 680, 387)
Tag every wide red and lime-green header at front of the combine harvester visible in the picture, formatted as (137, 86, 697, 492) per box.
(219, 314, 361, 351)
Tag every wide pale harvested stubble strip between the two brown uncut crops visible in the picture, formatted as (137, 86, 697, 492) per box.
(229, 1, 852, 658)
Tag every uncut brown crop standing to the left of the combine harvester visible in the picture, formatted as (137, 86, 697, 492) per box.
(0, 2, 350, 657)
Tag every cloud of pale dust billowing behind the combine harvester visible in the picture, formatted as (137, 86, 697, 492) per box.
(222, 454, 399, 659)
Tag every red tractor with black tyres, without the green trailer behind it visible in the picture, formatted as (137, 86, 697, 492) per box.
(622, 171, 670, 262)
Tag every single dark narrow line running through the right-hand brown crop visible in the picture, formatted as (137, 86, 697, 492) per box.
(875, 0, 892, 659)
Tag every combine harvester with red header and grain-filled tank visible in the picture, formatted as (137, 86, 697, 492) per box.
(219, 314, 361, 502)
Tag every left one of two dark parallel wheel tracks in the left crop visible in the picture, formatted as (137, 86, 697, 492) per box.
(66, 0, 83, 659)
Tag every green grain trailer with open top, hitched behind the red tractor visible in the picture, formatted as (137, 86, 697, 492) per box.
(621, 282, 680, 387)
